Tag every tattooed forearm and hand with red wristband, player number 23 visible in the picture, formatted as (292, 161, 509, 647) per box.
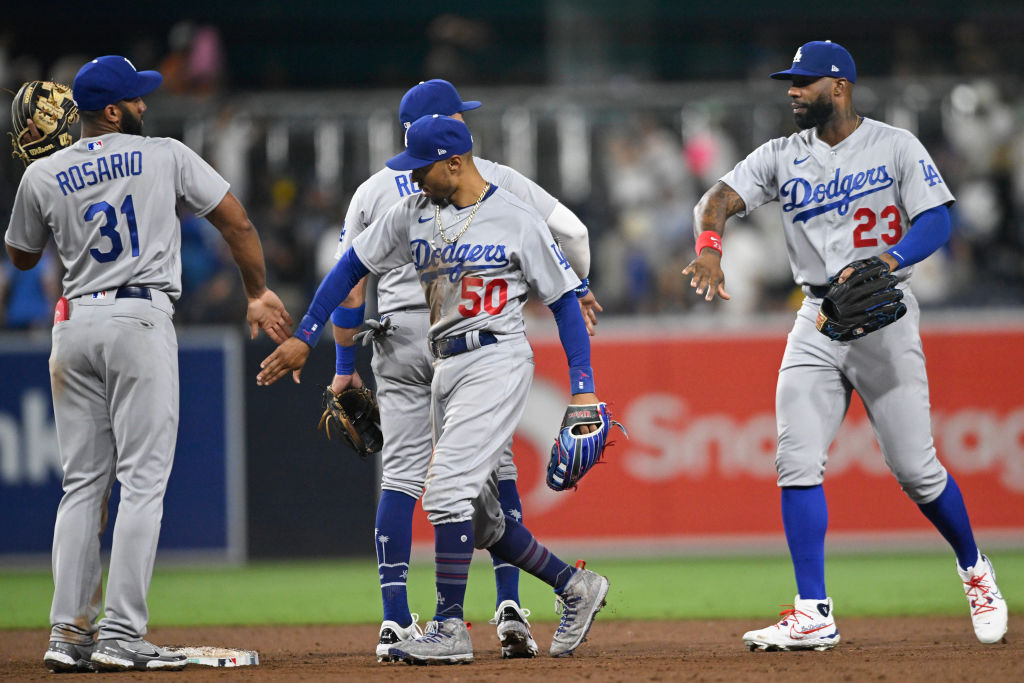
(683, 180, 744, 301)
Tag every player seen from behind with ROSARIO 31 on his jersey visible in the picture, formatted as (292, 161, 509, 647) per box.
(5, 55, 291, 672)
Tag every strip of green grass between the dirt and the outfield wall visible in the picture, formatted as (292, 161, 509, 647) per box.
(0, 550, 1024, 629)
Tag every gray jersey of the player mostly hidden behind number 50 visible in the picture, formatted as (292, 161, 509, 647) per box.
(335, 158, 558, 313)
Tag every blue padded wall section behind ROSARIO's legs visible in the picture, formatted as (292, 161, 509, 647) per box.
(0, 333, 238, 558)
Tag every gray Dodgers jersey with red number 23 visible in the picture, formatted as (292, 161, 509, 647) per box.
(722, 118, 953, 285)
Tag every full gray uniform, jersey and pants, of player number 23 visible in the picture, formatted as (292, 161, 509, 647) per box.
(722, 119, 953, 503)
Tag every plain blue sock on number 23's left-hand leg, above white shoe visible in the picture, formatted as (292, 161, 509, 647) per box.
(782, 484, 828, 600)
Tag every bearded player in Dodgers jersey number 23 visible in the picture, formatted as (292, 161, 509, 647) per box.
(683, 41, 1007, 650)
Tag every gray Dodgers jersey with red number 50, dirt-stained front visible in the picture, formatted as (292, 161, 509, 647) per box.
(352, 185, 580, 340)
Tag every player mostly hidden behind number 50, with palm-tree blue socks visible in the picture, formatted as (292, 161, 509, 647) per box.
(331, 79, 601, 661)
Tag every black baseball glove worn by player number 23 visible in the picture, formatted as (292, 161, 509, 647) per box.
(816, 256, 906, 341)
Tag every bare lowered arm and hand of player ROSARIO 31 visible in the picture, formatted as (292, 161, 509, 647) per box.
(207, 193, 292, 343)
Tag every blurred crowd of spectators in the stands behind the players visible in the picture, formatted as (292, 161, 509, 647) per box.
(0, 23, 1024, 330)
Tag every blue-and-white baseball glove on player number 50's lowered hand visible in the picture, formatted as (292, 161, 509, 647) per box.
(547, 403, 629, 490)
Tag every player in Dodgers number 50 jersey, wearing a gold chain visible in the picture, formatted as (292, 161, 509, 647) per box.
(257, 115, 608, 664)
